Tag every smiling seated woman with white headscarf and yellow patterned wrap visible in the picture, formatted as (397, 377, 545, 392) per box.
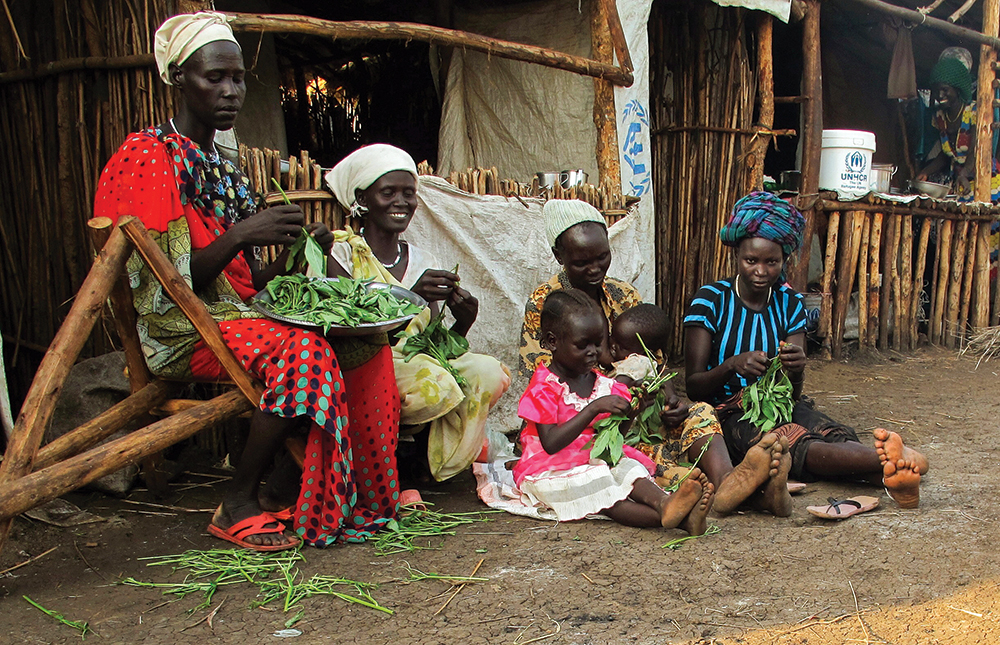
(326, 144, 510, 481)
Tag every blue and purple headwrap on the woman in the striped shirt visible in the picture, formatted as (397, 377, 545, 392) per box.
(719, 191, 806, 256)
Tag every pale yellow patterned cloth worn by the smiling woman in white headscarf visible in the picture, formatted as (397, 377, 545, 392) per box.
(334, 231, 510, 481)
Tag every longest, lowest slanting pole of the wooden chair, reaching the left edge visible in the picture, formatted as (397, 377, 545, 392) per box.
(0, 390, 254, 523)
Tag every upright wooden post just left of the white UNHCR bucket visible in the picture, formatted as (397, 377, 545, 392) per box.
(789, 0, 829, 291)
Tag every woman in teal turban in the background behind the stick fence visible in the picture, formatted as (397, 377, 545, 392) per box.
(916, 58, 1000, 203)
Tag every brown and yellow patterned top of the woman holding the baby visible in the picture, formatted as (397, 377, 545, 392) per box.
(518, 271, 642, 378)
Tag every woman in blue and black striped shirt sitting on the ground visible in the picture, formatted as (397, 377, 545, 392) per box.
(684, 192, 927, 516)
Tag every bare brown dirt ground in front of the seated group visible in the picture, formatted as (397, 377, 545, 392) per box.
(0, 350, 1000, 645)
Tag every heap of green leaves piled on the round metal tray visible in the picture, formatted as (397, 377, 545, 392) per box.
(267, 274, 422, 332)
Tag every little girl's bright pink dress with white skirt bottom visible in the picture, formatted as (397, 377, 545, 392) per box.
(514, 365, 655, 521)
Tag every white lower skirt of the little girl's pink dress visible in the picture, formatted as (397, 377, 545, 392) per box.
(519, 457, 649, 522)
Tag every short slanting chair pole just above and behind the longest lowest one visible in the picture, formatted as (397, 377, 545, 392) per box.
(33, 380, 178, 470)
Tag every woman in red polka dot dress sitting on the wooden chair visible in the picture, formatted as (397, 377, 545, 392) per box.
(94, 13, 399, 550)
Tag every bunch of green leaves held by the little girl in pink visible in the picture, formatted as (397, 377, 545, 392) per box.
(584, 336, 677, 466)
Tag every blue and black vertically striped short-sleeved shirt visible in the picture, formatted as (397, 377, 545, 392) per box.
(684, 278, 807, 405)
